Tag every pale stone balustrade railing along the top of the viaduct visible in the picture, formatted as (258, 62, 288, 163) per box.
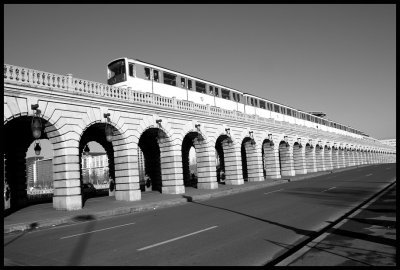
(4, 64, 392, 152)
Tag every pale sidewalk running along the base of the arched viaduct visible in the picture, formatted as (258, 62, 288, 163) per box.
(4, 166, 361, 233)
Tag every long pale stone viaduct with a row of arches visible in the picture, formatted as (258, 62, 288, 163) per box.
(3, 64, 396, 210)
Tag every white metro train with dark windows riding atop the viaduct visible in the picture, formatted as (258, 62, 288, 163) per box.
(107, 58, 368, 138)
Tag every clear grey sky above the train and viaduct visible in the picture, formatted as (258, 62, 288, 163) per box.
(4, 4, 396, 158)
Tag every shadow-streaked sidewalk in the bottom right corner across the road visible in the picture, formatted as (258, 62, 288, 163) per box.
(286, 181, 397, 266)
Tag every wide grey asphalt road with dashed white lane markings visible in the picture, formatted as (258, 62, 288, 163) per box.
(4, 164, 396, 266)
